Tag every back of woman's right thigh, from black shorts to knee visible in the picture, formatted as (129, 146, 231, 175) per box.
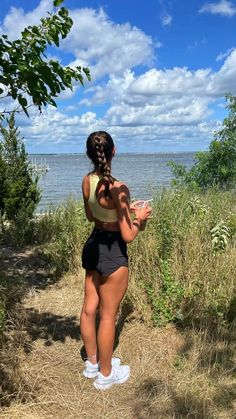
(99, 266, 129, 317)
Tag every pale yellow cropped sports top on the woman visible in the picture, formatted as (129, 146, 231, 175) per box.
(88, 174, 118, 223)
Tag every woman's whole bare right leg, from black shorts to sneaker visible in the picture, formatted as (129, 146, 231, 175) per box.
(97, 266, 128, 376)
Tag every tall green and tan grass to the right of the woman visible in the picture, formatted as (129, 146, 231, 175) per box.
(129, 188, 236, 328)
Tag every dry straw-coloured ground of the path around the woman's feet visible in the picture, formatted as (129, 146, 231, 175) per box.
(0, 248, 234, 419)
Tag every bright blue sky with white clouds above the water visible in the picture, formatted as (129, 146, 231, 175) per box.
(0, 0, 236, 153)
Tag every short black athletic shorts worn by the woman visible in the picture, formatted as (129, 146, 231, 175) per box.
(82, 228, 128, 276)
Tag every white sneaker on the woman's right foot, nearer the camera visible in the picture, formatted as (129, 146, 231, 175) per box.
(93, 365, 130, 390)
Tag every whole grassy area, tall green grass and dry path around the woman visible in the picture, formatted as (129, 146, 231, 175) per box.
(0, 190, 236, 419)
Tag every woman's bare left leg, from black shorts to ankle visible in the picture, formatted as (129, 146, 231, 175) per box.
(80, 271, 100, 364)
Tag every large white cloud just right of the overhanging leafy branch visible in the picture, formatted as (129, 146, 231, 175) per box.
(62, 9, 155, 80)
